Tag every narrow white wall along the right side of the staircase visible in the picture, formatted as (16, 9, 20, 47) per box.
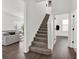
(48, 15, 56, 51)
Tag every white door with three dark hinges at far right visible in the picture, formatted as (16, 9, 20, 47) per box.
(68, 11, 77, 48)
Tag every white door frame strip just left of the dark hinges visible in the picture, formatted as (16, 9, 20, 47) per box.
(68, 13, 74, 48)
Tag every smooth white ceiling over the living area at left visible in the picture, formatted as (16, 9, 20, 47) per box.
(2, 0, 24, 16)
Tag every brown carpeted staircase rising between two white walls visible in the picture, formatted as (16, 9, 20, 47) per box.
(30, 14, 51, 55)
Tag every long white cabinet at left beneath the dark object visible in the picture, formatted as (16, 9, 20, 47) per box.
(2, 30, 20, 46)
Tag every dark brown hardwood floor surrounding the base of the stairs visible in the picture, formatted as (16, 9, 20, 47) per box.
(3, 37, 76, 59)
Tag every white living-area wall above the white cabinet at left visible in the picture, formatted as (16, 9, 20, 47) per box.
(2, 11, 24, 31)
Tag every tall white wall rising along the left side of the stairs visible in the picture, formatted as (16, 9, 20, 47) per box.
(28, 2, 46, 43)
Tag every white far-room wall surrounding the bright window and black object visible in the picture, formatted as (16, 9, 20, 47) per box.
(55, 14, 68, 36)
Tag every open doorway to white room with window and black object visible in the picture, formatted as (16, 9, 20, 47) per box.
(55, 14, 68, 37)
